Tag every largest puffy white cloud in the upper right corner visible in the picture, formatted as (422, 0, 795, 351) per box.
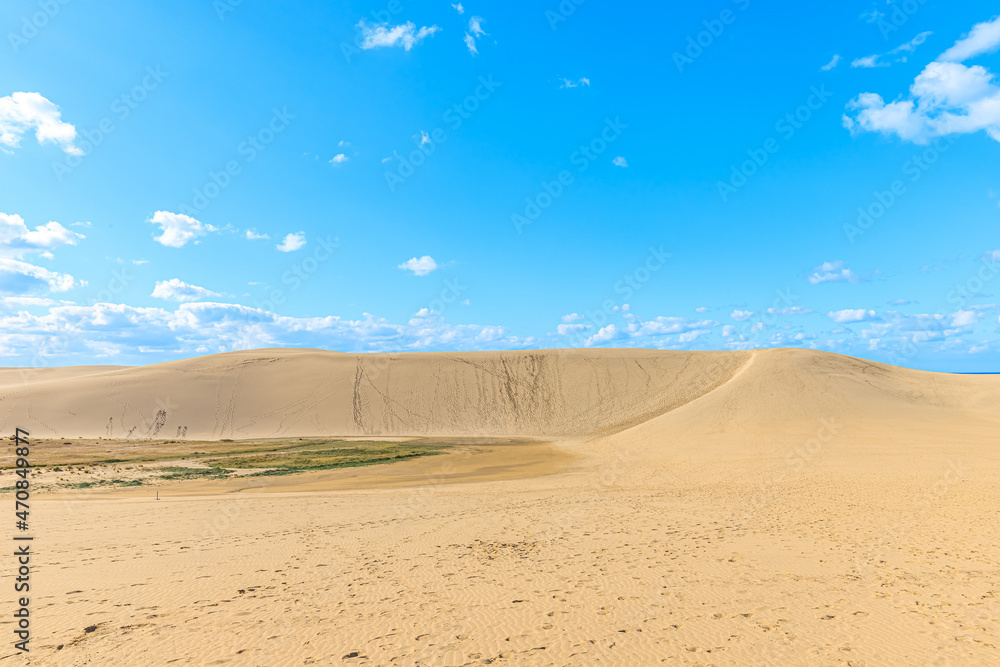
(843, 17, 1000, 144)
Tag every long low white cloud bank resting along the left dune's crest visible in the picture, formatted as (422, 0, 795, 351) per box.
(0, 301, 538, 365)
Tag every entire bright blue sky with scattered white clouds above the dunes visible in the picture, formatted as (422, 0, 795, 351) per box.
(0, 0, 1000, 371)
